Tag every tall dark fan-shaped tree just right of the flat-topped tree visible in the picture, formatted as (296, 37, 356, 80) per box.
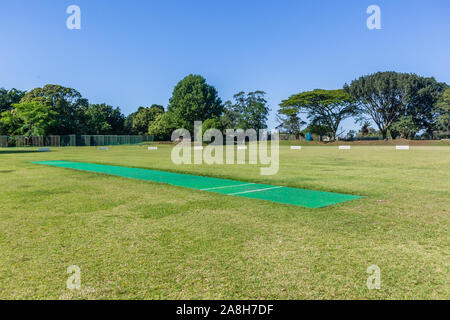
(344, 72, 445, 139)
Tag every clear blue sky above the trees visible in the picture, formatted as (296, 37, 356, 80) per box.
(0, 0, 450, 129)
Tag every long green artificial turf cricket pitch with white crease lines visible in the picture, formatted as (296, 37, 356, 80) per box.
(33, 161, 361, 208)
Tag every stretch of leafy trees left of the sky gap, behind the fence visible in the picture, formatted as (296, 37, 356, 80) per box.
(0, 74, 270, 140)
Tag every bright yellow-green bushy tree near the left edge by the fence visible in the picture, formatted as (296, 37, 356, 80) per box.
(1, 101, 57, 136)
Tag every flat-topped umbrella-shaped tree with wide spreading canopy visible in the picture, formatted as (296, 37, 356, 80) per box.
(279, 89, 357, 139)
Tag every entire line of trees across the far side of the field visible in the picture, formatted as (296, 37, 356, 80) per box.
(0, 72, 450, 140)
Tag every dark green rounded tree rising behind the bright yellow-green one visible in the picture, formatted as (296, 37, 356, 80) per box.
(21, 84, 88, 135)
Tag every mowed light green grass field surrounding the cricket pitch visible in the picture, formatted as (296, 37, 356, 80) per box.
(0, 145, 450, 299)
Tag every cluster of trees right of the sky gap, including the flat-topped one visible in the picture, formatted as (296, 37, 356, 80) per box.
(278, 72, 450, 139)
